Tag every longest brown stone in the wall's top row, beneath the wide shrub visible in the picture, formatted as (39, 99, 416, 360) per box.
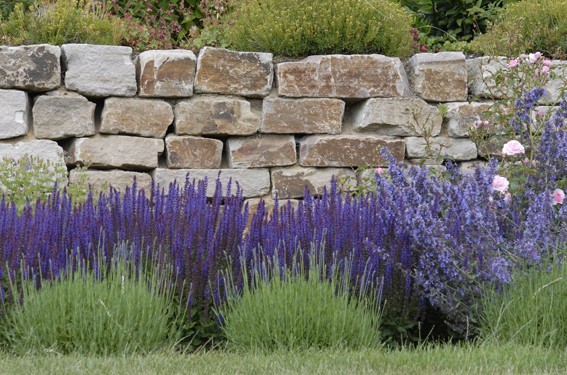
(276, 55, 412, 99)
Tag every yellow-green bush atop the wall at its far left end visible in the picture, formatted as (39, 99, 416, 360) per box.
(0, 0, 125, 45)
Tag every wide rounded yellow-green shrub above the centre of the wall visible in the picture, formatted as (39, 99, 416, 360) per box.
(226, 0, 413, 57)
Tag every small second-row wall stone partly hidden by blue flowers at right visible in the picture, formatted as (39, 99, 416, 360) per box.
(445, 102, 492, 138)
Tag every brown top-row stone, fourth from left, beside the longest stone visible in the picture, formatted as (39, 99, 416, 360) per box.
(195, 47, 274, 98)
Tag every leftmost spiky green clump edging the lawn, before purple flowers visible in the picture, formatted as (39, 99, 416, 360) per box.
(0, 243, 183, 355)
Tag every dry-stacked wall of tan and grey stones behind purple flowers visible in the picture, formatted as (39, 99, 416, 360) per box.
(0, 44, 562, 207)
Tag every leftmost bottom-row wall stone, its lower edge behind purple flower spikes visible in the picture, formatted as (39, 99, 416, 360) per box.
(69, 169, 152, 196)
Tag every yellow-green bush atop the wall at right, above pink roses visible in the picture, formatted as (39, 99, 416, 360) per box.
(471, 0, 567, 59)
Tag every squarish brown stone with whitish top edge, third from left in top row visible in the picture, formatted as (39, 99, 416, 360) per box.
(138, 49, 197, 98)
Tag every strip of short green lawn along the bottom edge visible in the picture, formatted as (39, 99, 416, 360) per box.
(0, 344, 567, 375)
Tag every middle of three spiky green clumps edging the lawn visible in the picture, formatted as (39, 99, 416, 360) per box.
(218, 245, 381, 351)
